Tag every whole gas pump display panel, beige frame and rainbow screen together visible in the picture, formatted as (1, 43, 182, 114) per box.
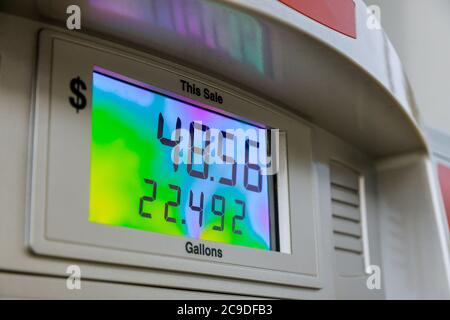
(25, 30, 322, 288)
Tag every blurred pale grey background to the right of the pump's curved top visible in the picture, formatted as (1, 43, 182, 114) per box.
(372, 0, 450, 135)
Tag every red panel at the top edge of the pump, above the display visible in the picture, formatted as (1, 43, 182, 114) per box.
(279, 0, 356, 39)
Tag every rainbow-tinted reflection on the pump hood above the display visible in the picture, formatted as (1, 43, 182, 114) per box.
(89, 0, 272, 76)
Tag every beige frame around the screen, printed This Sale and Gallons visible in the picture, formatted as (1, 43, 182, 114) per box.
(28, 30, 322, 288)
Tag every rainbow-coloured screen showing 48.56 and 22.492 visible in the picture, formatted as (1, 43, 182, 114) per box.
(89, 71, 275, 250)
